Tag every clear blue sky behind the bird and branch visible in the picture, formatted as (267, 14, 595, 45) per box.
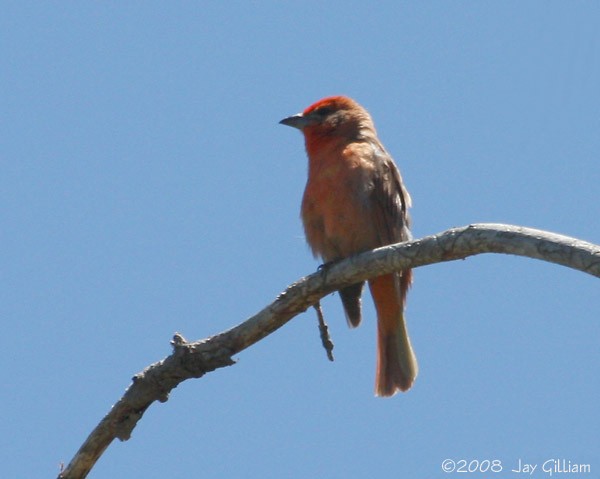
(0, 1, 600, 479)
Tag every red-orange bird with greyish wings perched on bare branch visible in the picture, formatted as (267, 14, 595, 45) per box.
(280, 96, 418, 397)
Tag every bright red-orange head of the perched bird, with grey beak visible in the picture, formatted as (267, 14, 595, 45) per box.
(279, 96, 375, 140)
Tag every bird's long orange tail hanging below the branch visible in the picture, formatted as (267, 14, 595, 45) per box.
(369, 271, 419, 397)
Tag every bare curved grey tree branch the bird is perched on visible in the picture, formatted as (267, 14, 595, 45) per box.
(59, 224, 600, 479)
